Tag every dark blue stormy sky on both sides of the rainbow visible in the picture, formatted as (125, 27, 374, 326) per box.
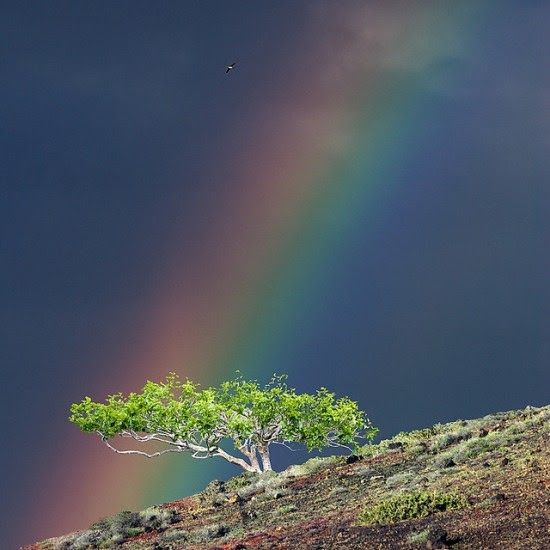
(0, 0, 550, 548)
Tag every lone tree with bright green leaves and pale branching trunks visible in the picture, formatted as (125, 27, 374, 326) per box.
(70, 373, 378, 472)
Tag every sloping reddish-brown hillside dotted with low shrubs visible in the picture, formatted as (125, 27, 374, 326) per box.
(26, 406, 550, 550)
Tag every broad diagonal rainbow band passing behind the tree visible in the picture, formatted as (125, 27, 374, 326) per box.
(28, 2, 490, 548)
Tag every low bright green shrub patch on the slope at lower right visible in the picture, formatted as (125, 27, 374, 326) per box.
(359, 491, 468, 525)
